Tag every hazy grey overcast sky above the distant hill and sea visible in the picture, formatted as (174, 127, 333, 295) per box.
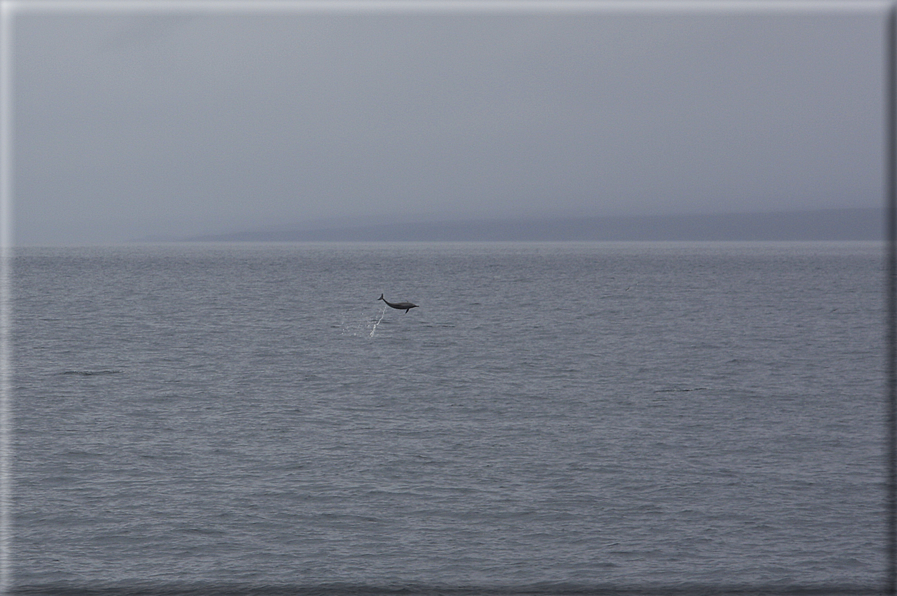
(13, 0, 885, 245)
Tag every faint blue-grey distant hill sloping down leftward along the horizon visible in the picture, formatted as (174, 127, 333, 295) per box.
(189, 208, 885, 242)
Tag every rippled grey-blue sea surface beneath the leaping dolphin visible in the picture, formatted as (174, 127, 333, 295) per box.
(11, 242, 887, 596)
